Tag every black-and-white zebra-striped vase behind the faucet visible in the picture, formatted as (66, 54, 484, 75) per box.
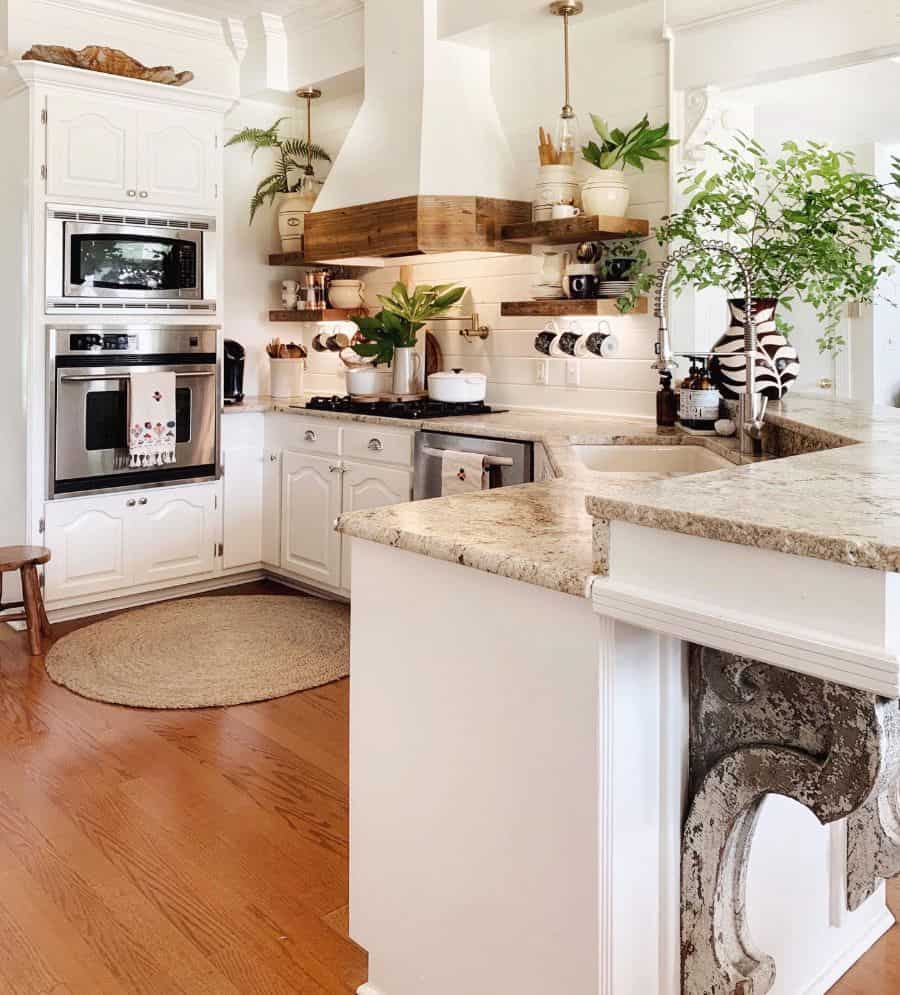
(709, 297, 800, 401)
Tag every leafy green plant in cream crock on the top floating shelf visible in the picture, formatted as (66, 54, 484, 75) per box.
(581, 114, 678, 218)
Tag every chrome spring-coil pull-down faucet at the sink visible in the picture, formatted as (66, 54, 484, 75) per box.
(653, 240, 766, 455)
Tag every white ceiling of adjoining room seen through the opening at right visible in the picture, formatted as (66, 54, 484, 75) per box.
(727, 59, 900, 146)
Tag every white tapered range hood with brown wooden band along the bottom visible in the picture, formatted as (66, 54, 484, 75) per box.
(306, 0, 529, 258)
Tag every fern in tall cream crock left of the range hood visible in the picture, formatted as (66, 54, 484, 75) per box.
(225, 117, 331, 252)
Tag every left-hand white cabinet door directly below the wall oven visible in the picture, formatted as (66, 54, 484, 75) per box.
(44, 496, 135, 602)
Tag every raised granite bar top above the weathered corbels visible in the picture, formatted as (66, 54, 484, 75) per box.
(587, 397, 900, 571)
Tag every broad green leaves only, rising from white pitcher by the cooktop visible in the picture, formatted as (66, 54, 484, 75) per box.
(353, 282, 466, 366)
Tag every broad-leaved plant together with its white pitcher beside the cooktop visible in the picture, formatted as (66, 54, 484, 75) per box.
(352, 282, 466, 394)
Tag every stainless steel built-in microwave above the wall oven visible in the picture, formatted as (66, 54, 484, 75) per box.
(46, 207, 216, 314)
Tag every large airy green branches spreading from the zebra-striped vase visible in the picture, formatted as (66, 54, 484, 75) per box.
(655, 134, 900, 353)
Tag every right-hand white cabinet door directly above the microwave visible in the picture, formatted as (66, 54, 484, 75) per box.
(138, 110, 218, 208)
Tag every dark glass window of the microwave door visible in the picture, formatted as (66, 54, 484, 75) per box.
(69, 234, 197, 291)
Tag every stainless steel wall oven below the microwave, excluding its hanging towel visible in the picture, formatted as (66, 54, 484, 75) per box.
(47, 325, 222, 498)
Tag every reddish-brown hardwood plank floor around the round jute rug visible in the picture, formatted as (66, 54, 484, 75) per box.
(0, 584, 900, 995)
